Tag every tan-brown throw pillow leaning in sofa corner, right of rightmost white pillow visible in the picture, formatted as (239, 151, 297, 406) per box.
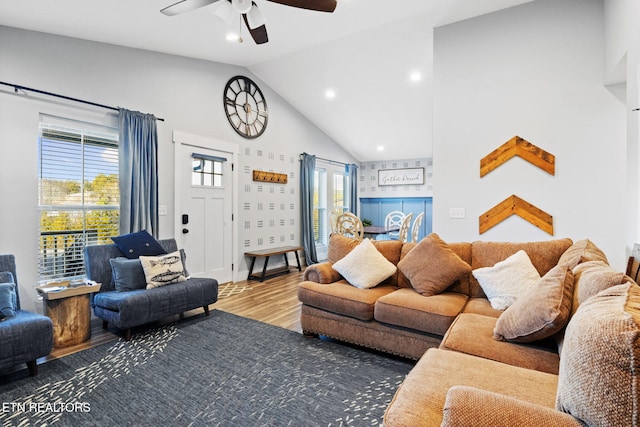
(493, 264, 573, 343)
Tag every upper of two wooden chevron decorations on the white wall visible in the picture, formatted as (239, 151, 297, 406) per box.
(480, 136, 556, 177)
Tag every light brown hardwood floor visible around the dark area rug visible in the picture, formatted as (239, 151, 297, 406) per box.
(45, 270, 303, 362)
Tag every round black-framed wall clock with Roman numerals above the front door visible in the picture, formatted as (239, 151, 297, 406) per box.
(224, 76, 269, 139)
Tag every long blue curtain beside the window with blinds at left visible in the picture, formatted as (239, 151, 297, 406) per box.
(118, 108, 158, 237)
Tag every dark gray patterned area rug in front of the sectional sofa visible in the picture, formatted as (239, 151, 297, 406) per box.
(0, 310, 413, 427)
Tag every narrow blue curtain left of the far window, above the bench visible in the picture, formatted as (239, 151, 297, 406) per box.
(300, 153, 318, 265)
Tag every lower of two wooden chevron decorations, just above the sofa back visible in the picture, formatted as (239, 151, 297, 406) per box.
(479, 194, 553, 236)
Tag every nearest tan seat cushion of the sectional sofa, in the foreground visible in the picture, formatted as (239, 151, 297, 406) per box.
(384, 348, 558, 427)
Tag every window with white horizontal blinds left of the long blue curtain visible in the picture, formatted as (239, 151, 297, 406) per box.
(38, 116, 120, 282)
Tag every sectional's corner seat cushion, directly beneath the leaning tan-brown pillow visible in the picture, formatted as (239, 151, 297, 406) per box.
(440, 313, 560, 374)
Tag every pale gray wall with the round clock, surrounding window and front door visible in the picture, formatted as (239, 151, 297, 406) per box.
(0, 26, 355, 310)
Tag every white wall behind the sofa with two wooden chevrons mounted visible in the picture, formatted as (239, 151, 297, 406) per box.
(433, 0, 627, 269)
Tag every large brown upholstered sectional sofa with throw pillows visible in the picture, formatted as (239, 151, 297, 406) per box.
(298, 235, 640, 427)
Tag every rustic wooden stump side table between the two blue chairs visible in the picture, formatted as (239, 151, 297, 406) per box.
(36, 282, 100, 347)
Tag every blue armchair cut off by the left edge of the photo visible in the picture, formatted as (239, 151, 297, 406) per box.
(0, 255, 53, 376)
